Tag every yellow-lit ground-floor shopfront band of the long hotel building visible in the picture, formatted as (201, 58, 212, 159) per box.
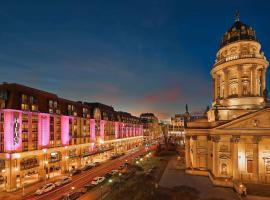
(0, 136, 143, 191)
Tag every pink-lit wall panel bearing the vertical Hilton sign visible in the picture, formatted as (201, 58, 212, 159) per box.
(1, 110, 22, 151)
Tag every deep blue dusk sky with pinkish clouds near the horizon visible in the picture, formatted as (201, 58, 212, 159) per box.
(0, 0, 270, 119)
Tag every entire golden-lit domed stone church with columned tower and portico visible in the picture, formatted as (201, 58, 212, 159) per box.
(185, 14, 270, 187)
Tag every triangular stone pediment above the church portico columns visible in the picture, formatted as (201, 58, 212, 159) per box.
(217, 108, 270, 129)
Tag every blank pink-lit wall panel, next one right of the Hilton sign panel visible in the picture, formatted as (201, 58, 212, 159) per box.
(38, 113, 50, 147)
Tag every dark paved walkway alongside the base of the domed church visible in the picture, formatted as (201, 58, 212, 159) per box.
(159, 157, 239, 200)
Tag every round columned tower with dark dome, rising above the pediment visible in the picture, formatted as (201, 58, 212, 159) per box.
(209, 15, 269, 121)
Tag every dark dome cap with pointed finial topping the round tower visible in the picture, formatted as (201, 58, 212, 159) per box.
(220, 18, 257, 48)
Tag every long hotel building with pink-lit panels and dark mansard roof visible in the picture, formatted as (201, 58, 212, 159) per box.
(0, 83, 143, 191)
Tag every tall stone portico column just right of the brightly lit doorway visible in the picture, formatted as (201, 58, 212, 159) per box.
(253, 136, 261, 181)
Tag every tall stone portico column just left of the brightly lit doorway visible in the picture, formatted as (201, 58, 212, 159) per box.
(231, 136, 240, 180)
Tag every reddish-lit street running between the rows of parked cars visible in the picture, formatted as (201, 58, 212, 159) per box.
(23, 146, 154, 200)
